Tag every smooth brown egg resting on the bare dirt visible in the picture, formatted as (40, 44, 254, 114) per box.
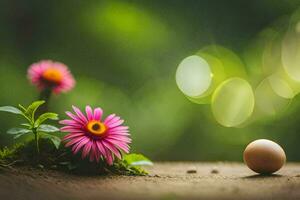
(244, 139, 286, 174)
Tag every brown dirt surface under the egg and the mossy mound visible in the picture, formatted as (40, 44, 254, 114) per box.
(0, 162, 300, 200)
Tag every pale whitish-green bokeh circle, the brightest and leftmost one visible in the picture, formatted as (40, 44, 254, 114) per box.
(176, 55, 212, 97)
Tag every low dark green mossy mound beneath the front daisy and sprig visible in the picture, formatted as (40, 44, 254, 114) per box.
(0, 139, 148, 176)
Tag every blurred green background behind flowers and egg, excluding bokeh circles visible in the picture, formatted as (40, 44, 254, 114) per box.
(0, 0, 300, 161)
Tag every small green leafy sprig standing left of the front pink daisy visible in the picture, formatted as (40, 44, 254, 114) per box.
(0, 101, 61, 155)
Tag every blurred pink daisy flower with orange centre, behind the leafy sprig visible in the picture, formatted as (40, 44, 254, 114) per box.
(28, 60, 75, 94)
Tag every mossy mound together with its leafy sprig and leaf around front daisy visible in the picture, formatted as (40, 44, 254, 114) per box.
(0, 101, 152, 175)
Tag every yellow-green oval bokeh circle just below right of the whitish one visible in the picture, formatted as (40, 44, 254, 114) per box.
(211, 77, 255, 127)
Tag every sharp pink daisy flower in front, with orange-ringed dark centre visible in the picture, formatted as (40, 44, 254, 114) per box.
(60, 106, 131, 165)
